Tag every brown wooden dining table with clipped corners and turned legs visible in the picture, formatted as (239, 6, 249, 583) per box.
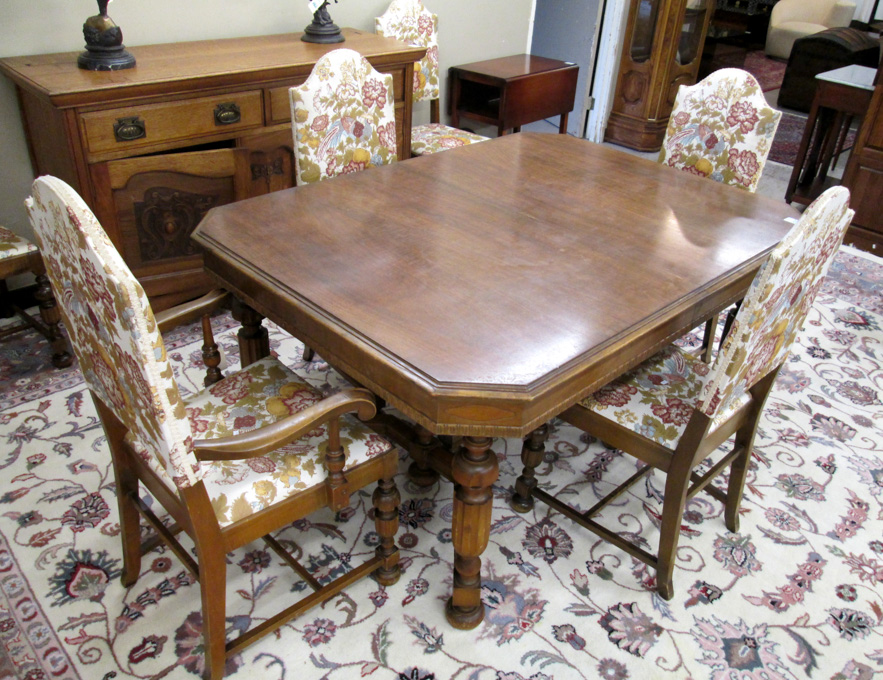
(193, 132, 799, 629)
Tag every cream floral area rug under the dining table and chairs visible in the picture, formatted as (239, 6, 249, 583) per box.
(0, 249, 883, 680)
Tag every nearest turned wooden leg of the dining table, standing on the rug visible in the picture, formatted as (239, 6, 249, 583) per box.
(445, 437, 499, 630)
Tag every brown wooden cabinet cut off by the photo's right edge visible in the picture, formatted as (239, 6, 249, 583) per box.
(843, 77, 883, 256)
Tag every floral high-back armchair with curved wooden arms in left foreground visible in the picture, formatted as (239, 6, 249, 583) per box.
(27, 177, 399, 679)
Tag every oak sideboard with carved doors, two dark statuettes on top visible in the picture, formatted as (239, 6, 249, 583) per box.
(0, 29, 425, 310)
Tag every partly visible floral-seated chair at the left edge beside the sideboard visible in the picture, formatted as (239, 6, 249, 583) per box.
(0, 227, 74, 368)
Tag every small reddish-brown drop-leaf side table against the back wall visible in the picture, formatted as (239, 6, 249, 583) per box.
(448, 54, 579, 135)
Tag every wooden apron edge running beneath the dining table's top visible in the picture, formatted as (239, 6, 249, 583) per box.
(205, 250, 763, 438)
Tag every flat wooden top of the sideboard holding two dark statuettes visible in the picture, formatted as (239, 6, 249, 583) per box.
(0, 28, 425, 108)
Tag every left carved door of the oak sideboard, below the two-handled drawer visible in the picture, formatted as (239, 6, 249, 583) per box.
(91, 149, 251, 310)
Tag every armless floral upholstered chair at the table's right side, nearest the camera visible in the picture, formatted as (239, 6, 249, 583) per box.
(512, 187, 853, 599)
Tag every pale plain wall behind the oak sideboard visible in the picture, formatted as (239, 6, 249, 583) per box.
(0, 0, 533, 243)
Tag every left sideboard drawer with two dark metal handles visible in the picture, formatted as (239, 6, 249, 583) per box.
(81, 90, 263, 155)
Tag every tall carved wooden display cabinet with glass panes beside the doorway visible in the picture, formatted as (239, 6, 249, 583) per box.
(604, 0, 713, 151)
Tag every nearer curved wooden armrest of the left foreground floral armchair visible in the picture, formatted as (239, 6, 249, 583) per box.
(193, 388, 377, 461)
